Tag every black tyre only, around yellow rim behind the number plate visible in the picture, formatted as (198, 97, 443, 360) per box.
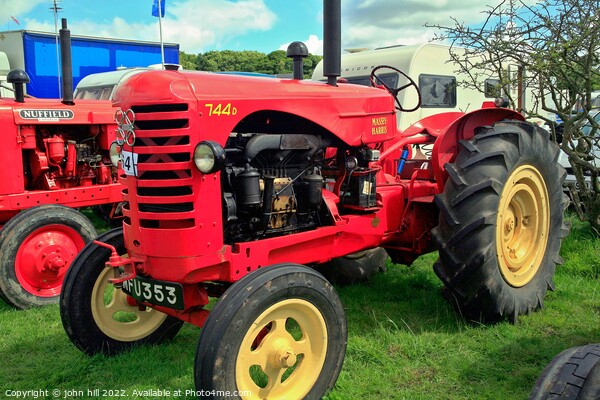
(60, 228, 183, 355)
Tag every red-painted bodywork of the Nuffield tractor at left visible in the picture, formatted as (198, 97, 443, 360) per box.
(0, 99, 121, 226)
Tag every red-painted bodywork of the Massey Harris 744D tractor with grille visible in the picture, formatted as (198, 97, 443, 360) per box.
(114, 71, 522, 325)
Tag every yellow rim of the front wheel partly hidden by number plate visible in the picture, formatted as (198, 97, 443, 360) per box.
(91, 268, 167, 342)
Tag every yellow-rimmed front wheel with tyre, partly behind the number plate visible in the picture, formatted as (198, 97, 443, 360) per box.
(60, 228, 183, 355)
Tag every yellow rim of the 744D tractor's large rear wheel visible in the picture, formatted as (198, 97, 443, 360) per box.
(496, 165, 550, 287)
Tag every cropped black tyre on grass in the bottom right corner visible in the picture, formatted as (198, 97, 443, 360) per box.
(529, 344, 600, 400)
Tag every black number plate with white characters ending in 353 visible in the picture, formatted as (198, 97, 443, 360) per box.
(123, 276, 183, 310)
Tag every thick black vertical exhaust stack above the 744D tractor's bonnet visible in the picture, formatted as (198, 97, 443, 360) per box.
(323, 0, 342, 86)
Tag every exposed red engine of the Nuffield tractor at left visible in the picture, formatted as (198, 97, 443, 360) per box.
(24, 126, 116, 190)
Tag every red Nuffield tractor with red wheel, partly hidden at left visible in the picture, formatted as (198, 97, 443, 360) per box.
(0, 20, 122, 308)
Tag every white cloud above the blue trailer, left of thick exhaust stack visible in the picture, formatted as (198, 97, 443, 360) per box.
(20, 0, 277, 54)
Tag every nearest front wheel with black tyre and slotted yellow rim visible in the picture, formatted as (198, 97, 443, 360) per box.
(195, 264, 347, 399)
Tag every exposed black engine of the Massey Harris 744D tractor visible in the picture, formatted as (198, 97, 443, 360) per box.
(222, 133, 327, 243)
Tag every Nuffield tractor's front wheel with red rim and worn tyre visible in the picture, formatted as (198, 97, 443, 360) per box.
(0, 204, 96, 309)
